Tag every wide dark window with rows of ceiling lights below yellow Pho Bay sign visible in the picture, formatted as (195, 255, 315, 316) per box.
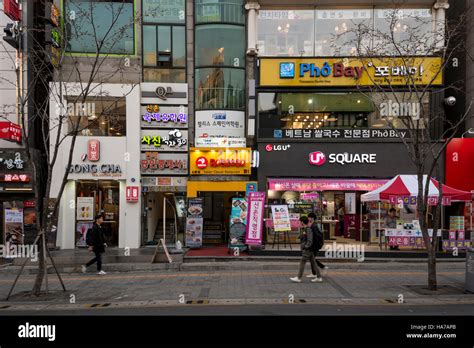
(258, 92, 429, 134)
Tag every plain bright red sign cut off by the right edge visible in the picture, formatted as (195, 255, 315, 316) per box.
(446, 138, 474, 191)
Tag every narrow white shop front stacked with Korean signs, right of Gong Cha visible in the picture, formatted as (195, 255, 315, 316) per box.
(140, 83, 189, 245)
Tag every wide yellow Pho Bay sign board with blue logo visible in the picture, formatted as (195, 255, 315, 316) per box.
(260, 57, 443, 87)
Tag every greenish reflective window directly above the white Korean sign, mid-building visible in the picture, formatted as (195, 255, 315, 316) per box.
(195, 68, 245, 110)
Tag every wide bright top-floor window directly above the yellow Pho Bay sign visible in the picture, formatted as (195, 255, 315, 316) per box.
(257, 8, 433, 56)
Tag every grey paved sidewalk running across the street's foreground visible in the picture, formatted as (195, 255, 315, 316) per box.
(0, 261, 474, 314)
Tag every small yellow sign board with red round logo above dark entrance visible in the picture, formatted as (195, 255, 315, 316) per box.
(189, 148, 252, 175)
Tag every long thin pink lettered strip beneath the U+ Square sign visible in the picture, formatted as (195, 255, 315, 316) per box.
(268, 179, 388, 192)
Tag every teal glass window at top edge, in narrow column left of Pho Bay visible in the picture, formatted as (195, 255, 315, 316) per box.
(195, 0, 245, 24)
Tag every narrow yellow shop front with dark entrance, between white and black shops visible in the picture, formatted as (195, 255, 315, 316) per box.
(186, 147, 257, 246)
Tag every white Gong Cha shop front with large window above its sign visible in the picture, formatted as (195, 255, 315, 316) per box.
(50, 84, 141, 249)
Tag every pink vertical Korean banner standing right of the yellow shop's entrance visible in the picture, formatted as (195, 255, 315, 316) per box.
(245, 192, 265, 245)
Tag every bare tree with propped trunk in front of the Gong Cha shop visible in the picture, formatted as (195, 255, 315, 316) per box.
(1, 0, 139, 296)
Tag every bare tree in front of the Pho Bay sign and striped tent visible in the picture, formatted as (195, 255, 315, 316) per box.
(334, 7, 471, 290)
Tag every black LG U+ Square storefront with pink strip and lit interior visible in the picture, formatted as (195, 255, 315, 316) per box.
(258, 142, 415, 243)
